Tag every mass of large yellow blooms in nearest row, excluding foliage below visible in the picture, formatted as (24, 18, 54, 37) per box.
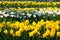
(0, 20, 60, 38)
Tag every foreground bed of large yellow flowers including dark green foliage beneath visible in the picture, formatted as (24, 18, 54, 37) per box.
(0, 19, 60, 40)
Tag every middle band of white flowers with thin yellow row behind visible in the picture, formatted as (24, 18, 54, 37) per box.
(0, 8, 60, 22)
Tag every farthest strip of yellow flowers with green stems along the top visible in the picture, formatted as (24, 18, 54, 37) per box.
(0, 1, 60, 8)
